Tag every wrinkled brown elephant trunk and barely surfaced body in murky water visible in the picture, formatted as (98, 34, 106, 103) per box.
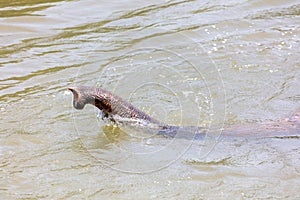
(68, 86, 300, 139)
